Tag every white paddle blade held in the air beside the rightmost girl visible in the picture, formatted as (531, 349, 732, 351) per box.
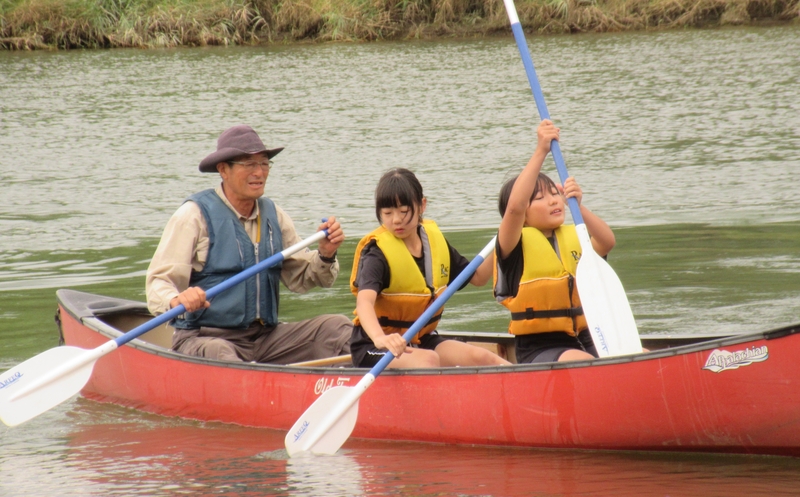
(575, 251, 642, 357)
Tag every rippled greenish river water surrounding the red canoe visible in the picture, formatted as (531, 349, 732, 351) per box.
(0, 27, 800, 496)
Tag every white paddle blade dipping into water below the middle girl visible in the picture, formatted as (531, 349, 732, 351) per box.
(284, 386, 358, 457)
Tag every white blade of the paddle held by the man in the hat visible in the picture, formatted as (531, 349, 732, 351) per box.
(0, 346, 95, 426)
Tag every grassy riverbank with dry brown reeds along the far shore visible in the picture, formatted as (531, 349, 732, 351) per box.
(0, 0, 800, 50)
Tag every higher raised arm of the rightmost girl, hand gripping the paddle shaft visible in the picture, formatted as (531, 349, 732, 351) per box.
(497, 119, 559, 258)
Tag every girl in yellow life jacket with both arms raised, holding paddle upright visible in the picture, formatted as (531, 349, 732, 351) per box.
(494, 119, 615, 363)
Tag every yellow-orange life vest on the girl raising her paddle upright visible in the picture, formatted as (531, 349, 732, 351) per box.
(494, 225, 587, 336)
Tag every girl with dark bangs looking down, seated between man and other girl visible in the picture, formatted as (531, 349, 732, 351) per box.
(350, 169, 509, 368)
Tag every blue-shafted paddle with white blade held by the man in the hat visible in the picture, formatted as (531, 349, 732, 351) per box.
(0, 230, 328, 426)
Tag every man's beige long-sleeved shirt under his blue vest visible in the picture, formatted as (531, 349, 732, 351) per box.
(145, 185, 339, 314)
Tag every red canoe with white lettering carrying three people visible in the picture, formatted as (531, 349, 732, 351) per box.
(57, 290, 800, 457)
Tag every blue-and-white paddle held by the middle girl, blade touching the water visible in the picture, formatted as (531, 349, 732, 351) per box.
(284, 234, 495, 457)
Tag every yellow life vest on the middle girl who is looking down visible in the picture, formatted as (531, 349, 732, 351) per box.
(350, 220, 450, 343)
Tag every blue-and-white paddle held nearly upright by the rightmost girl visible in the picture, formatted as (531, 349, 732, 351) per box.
(503, 0, 642, 357)
